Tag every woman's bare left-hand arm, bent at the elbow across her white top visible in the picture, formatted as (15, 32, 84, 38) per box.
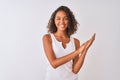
(43, 34, 84, 68)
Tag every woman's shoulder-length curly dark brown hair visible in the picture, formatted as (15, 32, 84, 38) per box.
(47, 6, 78, 36)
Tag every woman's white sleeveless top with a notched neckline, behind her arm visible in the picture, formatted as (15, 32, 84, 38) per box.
(45, 34, 77, 80)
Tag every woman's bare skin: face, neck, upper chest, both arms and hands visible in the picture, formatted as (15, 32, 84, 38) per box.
(43, 11, 95, 74)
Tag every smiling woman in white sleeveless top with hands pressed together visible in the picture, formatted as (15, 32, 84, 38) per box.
(43, 6, 95, 80)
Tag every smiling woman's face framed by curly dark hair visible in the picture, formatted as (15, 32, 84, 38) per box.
(55, 10, 69, 31)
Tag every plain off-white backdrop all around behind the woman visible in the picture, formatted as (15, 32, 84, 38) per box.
(0, 0, 120, 80)
